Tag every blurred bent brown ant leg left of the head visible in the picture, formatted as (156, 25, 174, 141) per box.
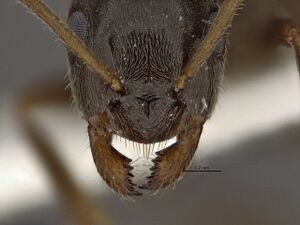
(18, 81, 111, 225)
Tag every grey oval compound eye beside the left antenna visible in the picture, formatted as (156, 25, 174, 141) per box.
(68, 11, 88, 42)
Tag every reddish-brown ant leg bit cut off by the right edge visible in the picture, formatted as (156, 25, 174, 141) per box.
(278, 21, 300, 73)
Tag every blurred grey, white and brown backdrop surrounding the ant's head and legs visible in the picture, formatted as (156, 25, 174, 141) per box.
(0, 0, 300, 225)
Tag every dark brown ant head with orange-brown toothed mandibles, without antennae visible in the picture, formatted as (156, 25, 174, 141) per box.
(68, 0, 226, 196)
